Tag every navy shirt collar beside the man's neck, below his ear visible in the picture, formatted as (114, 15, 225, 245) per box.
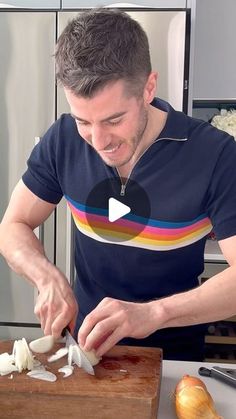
(151, 98, 189, 141)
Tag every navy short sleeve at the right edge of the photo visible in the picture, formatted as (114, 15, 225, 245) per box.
(207, 136, 236, 240)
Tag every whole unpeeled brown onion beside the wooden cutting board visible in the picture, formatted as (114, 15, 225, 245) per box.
(175, 375, 223, 419)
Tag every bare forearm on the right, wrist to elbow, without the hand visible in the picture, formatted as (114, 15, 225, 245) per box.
(156, 265, 236, 329)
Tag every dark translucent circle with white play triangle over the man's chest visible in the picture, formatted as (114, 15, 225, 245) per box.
(86, 177, 151, 242)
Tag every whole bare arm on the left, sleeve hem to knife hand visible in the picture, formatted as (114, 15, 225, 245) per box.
(0, 181, 78, 337)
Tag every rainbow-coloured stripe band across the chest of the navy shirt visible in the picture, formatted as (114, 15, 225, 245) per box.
(65, 196, 212, 251)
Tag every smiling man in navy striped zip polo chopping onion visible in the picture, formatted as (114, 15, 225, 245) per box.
(0, 9, 236, 360)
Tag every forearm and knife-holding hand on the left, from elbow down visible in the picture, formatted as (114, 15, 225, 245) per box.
(0, 222, 78, 337)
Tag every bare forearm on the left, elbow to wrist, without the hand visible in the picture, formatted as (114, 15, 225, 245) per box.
(0, 223, 61, 288)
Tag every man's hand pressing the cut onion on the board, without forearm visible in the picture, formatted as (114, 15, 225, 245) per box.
(78, 297, 157, 356)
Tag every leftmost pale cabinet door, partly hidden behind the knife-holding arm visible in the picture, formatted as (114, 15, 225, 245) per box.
(0, 11, 56, 338)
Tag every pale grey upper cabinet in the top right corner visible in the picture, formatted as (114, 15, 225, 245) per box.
(193, 0, 236, 100)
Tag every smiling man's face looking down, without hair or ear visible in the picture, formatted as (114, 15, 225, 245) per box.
(65, 81, 148, 167)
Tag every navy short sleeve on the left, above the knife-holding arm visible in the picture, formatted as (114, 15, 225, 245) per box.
(22, 120, 63, 204)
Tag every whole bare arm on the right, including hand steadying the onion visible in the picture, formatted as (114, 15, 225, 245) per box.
(79, 236, 236, 356)
